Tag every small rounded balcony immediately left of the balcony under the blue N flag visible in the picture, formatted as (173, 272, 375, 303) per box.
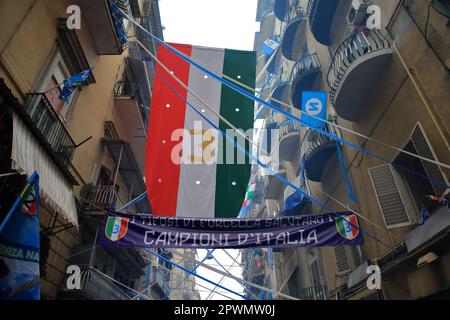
(278, 120, 300, 161)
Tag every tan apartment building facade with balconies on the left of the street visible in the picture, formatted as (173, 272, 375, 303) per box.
(0, 0, 162, 299)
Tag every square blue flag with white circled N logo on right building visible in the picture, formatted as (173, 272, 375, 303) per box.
(302, 91, 327, 128)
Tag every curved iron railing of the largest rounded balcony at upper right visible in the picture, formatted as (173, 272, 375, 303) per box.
(327, 29, 391, 104)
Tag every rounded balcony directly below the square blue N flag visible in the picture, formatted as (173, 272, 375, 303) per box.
(301, 124, 337, 182)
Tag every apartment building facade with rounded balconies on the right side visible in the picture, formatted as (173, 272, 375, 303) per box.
(251, 0, 450, 299)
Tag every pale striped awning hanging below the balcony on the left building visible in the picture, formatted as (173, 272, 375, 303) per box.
(11, 112, 78, 228)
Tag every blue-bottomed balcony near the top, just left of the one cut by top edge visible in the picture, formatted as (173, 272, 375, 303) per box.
(281, 7, 308, 61)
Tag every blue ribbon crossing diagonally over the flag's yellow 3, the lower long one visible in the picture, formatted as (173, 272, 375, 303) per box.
(155, 72, 396, 252)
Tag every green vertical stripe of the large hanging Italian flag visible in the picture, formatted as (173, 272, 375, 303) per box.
(214, 49, 256, 218)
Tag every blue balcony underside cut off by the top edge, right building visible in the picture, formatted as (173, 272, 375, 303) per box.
(307, 0, 342, 46)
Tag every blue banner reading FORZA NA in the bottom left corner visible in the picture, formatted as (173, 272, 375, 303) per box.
(0, 172, 40, 300)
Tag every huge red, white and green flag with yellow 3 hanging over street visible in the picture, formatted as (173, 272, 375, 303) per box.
(145, 44, 256, 218)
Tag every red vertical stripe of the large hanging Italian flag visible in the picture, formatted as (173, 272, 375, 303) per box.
(145, 44, 192, 216)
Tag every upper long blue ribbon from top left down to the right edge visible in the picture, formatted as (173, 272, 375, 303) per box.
(111, 2, 450, 189)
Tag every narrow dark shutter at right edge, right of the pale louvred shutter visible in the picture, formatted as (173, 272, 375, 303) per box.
(411, 124, 448, 196)
